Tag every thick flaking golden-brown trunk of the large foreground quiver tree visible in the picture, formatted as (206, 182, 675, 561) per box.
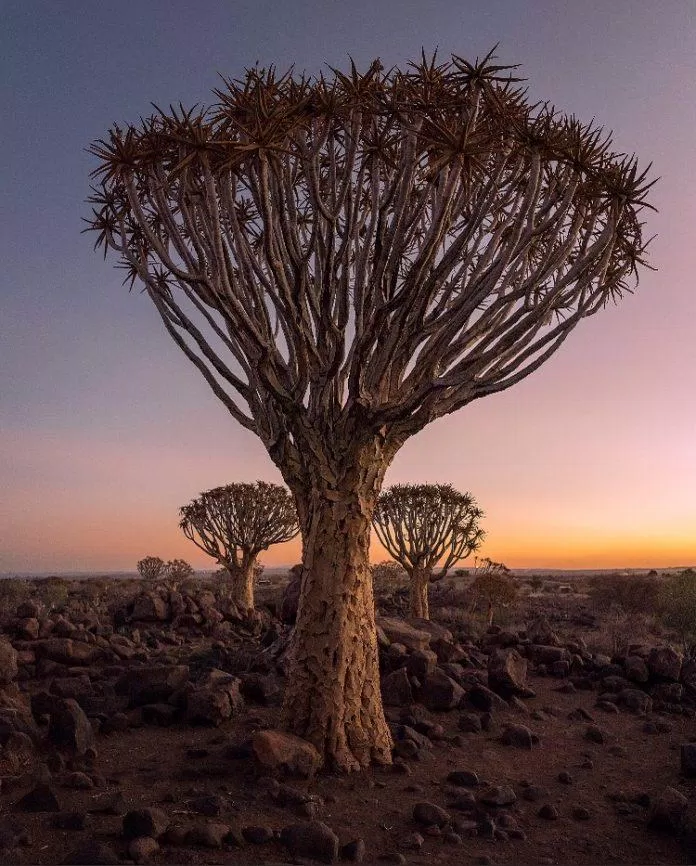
(283, 438, 392, 771)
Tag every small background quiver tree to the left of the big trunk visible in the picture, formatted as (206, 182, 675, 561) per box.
(179, 481, 300, 610)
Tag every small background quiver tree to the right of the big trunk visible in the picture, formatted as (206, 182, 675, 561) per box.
(372, 484, 485, 619)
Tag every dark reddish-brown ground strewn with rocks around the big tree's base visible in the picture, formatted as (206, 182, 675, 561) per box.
(0, 581, 696, 864)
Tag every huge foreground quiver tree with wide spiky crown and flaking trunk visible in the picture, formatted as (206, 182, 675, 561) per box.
(84, 49, 649, 769)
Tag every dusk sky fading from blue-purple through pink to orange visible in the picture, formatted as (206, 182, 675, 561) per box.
(0, 0, 696, 573)
